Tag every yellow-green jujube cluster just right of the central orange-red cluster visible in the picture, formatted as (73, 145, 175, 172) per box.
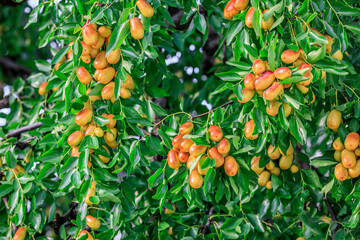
(250, 143, 299, 189)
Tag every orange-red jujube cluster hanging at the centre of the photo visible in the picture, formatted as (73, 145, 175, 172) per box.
(167, 122, 239, 188)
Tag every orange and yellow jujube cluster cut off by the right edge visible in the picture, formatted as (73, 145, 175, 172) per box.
(326, 109, 360, 181)
